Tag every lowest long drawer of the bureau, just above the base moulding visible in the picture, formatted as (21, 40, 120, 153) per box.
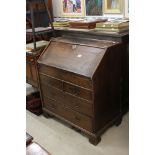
(43, 97, 92, 132)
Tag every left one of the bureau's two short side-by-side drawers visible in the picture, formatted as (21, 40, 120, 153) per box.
(40, 74, 63, 90)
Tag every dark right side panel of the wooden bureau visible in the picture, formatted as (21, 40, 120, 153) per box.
(93, 45, 121, 132)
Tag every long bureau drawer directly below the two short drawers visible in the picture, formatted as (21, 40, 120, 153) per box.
(41, 85, 93, 116)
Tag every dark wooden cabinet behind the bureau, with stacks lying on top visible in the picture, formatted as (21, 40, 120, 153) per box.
(55, 29, 129, 115)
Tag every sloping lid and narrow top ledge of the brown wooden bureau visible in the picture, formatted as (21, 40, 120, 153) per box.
(38, 38, 118, 78)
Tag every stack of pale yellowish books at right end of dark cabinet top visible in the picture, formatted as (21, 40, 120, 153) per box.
(95, 19, 129, 33)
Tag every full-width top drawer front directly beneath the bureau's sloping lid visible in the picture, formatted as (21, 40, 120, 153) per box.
(39, 64, 92, 89)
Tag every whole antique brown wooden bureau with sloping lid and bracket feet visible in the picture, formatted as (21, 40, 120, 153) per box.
(38, 37, 121, 145)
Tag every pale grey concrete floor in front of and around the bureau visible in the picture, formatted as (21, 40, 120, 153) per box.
(26, 111, 129, 155)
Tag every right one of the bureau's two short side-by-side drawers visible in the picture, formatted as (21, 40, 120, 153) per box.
(63, 82, 92, 101)
